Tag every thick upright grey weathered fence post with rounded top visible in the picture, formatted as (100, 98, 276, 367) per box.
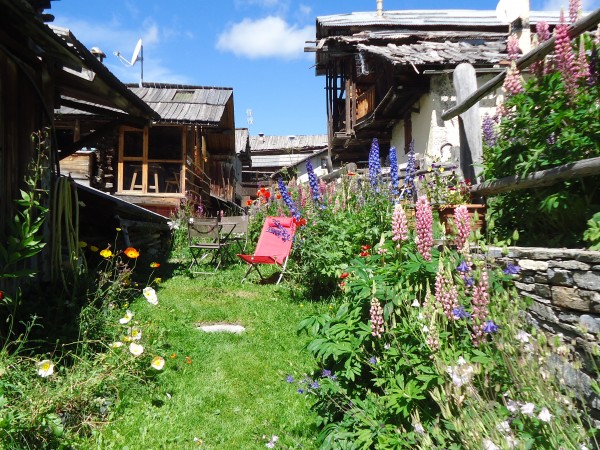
(452, 63, 483, 184)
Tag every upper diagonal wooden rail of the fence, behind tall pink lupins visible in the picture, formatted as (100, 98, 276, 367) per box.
(442, 8, 600, 120)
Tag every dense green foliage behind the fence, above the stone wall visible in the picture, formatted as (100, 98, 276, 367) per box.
(484, 58, 600, 246)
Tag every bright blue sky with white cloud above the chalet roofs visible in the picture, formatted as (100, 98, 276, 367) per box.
(51, 0, 600, 135)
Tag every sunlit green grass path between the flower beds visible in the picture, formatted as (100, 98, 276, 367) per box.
(89, 266, 322, 450)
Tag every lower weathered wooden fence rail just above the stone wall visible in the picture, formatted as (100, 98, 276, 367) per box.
(471, 157, 600, 197)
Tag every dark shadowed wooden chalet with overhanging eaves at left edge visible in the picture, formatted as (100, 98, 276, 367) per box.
(0, 0, 162, 282)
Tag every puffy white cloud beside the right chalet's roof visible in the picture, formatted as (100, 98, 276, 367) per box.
(217, 16, 315, 59)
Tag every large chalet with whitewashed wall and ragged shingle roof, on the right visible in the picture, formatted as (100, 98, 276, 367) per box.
(305, 10, 558, 162)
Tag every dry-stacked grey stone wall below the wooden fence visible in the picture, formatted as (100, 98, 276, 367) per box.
(496, 247, 600, 418)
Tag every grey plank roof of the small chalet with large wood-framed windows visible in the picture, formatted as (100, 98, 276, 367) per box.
(127, 83, 233, 126)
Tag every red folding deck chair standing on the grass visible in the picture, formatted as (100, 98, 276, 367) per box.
(237, 217, 296, 284)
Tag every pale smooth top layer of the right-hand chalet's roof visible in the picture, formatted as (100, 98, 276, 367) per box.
(317, 9, 559, 32)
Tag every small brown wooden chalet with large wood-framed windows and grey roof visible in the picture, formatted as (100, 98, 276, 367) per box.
(59, 82, 241, 216)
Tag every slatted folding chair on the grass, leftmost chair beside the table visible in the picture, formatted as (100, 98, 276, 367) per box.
(188, 217, 229, 274)
